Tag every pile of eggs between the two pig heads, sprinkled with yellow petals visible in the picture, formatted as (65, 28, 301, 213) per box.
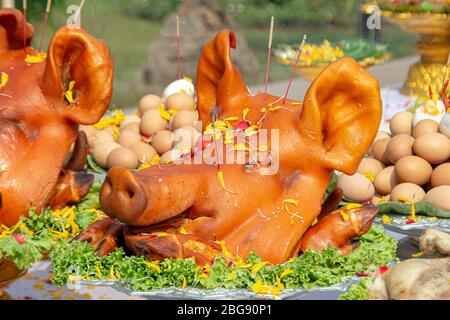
(80, 79, 201, 169)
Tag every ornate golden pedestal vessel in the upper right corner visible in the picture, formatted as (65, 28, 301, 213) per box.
(362, 3, 450, 97)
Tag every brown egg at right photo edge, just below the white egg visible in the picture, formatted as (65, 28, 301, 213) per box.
(413, 133, 450, 164)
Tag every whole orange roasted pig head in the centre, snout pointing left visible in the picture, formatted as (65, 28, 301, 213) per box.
(100, 30, 381, 263)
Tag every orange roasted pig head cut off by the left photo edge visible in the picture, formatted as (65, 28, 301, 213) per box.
(0, 9, 113, 225)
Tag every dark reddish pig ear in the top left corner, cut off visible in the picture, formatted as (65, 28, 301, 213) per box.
(0, 9, 34, 52)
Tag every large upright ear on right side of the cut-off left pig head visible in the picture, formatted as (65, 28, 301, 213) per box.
(43, 26, 114, 125)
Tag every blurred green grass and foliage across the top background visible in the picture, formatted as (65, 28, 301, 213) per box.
(23, 0, 416, 106)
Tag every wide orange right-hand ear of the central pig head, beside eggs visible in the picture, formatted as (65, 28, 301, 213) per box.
(299, 58, 382, 174)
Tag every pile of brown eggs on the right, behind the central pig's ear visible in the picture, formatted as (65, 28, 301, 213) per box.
(337, 100, 450, 211)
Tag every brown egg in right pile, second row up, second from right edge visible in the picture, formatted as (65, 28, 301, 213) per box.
(395, 156, 433, 186)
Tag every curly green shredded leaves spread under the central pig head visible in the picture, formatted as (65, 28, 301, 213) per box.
(51, 226, 397, 291)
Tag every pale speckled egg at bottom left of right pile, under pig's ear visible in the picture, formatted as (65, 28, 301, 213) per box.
(337, 173, 375, 202)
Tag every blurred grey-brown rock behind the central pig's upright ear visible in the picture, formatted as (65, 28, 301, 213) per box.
(136, 0, 258, 94)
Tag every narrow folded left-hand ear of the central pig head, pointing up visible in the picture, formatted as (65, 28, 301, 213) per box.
(197, 30, 248, 124)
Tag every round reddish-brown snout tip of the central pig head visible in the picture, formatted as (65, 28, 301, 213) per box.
(100, 167, 148, 225)
